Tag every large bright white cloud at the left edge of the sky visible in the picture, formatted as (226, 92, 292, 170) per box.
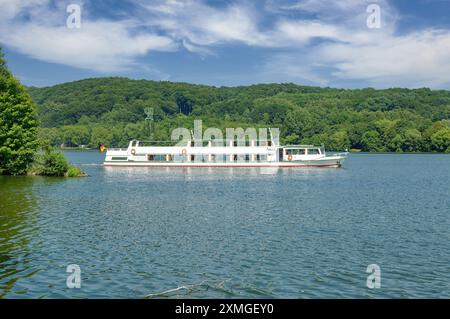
(0, 21, 175, 72)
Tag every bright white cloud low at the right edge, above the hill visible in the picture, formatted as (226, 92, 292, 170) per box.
(316, 30, 450, 87)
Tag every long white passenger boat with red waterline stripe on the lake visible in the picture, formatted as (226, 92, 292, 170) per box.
(104, 140, 347, 167)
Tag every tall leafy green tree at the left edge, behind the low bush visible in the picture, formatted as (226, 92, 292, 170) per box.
(0, 51, 38, 175)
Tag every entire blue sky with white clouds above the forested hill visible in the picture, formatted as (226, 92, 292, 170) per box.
(0, 0, 450, 89)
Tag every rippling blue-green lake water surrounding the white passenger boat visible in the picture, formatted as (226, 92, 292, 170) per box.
(0, 151, 450, 298)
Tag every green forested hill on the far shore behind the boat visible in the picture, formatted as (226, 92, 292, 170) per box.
(28, 78, 450, 152)
